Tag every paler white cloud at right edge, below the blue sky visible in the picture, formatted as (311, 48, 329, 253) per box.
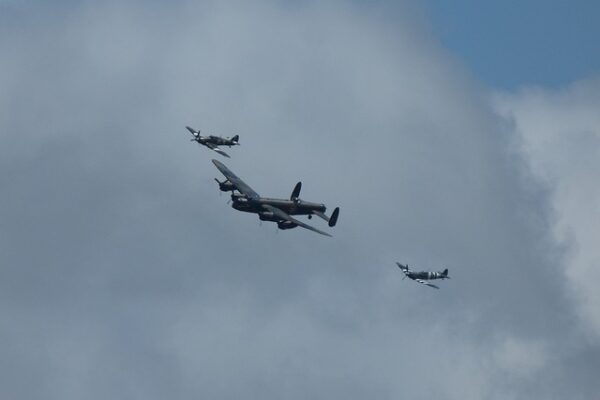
(496, 78, 600, 342)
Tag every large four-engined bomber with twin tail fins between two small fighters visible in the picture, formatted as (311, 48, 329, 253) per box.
(212, 160, 340, 236)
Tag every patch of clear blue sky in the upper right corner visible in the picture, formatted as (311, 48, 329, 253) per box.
(423, 0, 600, 90)
